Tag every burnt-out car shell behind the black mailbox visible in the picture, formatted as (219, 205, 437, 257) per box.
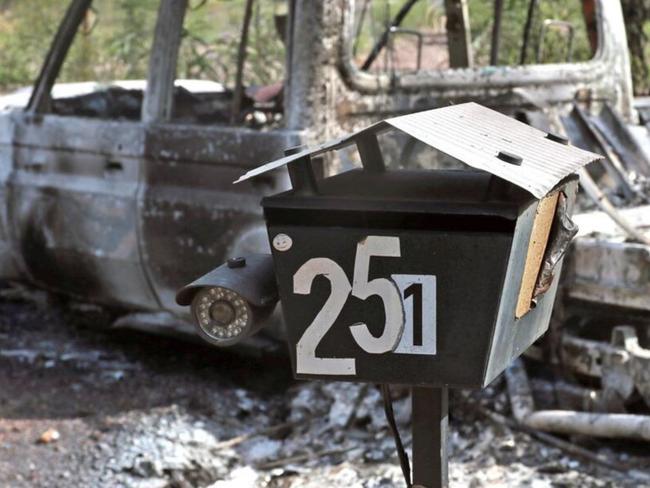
(0, 0, 650, 346)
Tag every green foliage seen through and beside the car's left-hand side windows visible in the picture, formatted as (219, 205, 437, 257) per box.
(0, 0, 284, 91)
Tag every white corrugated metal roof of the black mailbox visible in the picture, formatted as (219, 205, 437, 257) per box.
(236, 103, 602, 198)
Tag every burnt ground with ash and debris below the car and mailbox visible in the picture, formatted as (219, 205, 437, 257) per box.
(0, 288, 650, 488)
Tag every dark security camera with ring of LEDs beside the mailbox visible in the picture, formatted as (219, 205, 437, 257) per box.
(176, 254, 278, 346)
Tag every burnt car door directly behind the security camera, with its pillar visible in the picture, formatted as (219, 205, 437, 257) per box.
(138, 0, 300, 315)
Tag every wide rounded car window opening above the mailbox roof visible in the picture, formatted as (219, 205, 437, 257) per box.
(350, 0, 598, 77)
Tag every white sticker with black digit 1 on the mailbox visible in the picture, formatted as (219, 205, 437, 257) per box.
(391, 275, 436, 356)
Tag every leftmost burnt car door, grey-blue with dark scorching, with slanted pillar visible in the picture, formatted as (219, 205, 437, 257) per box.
(12, 0, 159, 309)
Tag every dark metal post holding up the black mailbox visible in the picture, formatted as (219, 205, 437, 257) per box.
(412, 387, 449, 488)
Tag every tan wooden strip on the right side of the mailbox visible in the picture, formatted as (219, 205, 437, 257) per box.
(515, 191, 560, 318)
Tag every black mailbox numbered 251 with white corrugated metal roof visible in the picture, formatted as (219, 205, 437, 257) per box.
(235, 103, 600, 387)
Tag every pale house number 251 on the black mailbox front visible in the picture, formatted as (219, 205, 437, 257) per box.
(293, 236, 436, 375)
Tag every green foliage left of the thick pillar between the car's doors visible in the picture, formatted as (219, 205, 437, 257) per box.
(0, 0, 158, 90)
